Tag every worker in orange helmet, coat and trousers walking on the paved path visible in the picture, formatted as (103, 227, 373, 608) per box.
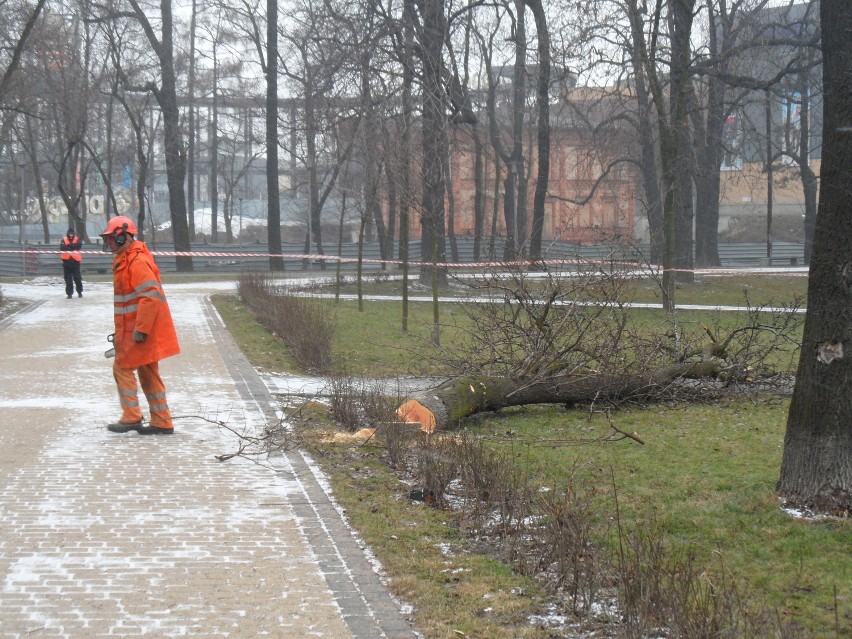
(101, 215, 180, 435)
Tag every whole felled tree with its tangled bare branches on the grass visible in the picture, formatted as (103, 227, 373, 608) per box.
(412, 264, 804, 428)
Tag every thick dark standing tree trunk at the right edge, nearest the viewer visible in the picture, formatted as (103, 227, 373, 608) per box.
(777, 0, 852, 514)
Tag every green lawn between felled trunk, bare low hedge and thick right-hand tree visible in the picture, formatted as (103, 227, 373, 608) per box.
(471, 400, 852, 636)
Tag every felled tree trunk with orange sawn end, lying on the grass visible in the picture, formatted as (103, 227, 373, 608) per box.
(397, 359, 721, 432)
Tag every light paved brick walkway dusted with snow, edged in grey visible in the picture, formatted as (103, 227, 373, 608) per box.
(0, 280, 416, 639)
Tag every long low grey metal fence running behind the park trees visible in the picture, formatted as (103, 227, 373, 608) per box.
(0, 236, 804, 277)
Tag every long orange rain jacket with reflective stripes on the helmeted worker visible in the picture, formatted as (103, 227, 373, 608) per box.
(112, 240, 180, 368)
